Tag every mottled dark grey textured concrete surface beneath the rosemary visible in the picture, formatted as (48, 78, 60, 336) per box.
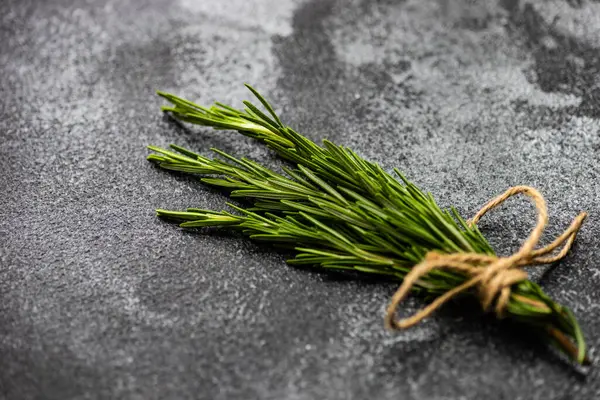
(0, 0, 600, 400)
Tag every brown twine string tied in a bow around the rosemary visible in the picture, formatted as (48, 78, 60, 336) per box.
(385, 186, 587, 329)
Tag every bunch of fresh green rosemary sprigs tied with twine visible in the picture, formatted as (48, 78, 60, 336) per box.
(148, 85, 588, 364)
